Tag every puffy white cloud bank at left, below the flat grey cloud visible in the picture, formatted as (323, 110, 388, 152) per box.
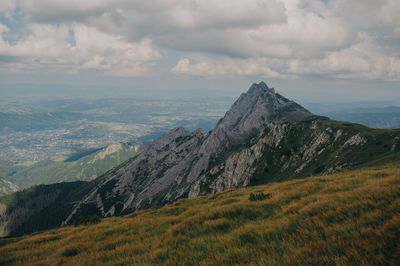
(0, 24, 160, 76)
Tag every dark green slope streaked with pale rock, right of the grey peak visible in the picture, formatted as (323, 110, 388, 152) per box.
(194, 120, 400, 194)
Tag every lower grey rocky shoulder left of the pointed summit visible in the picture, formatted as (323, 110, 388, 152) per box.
(62, 127, 204, 225)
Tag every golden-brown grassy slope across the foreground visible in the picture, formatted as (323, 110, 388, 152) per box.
(0, 160, 400, 265)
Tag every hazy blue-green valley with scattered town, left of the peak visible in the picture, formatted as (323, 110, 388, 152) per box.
(0, 96, 230, 195)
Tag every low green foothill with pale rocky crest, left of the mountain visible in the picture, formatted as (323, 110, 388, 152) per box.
(7, 144, 136, 188)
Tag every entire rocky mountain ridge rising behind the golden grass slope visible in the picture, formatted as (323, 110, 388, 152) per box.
(0, 82, 400, 235)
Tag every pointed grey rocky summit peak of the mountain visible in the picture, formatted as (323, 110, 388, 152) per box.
(202, 82, 317, 155)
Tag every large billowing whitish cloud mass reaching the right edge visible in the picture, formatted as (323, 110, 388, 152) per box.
(170, 0, 400, 81)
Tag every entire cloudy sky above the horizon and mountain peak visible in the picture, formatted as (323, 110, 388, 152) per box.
(0, 0, 400, 100)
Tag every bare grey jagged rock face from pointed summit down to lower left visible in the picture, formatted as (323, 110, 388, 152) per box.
(63, 82, 316, 224)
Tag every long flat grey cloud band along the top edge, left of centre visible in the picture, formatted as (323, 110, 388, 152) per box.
(20, 0, 286, 31)
